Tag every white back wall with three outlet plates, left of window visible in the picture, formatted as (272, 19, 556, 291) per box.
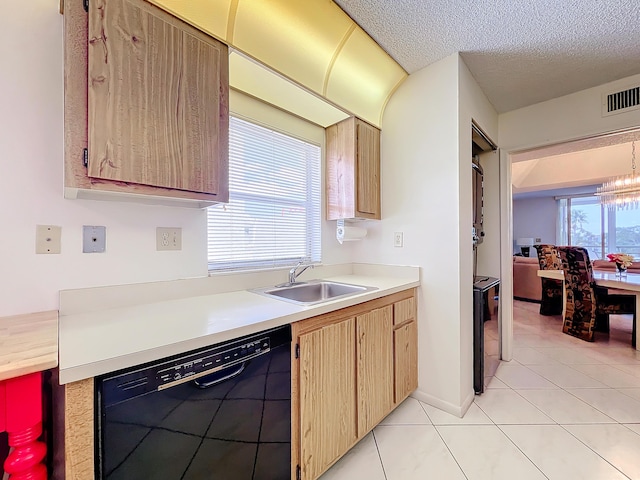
(0, 0, 351, 316)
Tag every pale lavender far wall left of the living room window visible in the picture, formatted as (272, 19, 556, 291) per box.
(513, 197, 558, 253)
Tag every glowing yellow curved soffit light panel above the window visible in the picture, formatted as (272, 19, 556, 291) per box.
(146, 0, 407, 127)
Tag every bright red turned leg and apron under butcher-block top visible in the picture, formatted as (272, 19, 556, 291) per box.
(0, 372, 47, 480)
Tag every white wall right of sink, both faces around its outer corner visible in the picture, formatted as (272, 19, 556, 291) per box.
(354, 54, 497, 414)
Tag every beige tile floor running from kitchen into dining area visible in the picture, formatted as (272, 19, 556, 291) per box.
(321, 301, 640, 480)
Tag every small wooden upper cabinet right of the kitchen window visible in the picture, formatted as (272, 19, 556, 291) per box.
(326, 117, 380, 220)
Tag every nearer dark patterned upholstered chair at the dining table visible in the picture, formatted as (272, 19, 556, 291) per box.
(557, 247, 636, 346)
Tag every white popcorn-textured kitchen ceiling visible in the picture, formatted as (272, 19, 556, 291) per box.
(335, 0, 640, 113)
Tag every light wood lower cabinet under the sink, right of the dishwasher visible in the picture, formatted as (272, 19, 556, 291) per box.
(291, 289, 418, 480)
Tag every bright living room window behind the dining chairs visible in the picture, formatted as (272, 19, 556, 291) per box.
(557, 195, 640, 260)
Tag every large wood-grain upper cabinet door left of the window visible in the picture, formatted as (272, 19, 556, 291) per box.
(88, 0, 228, 196)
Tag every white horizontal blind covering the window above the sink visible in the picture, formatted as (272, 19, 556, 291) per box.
(207, 117, 321, 270)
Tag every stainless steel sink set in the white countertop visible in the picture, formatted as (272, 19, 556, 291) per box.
(252, 280, 377, 305)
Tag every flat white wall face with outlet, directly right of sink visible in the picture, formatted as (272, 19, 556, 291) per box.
(355, 56, 460, 409)
